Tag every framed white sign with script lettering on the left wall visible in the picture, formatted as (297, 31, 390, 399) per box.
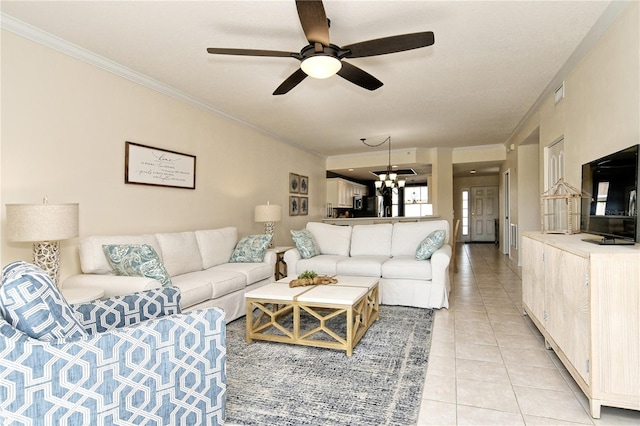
(124, 142, 196, 189)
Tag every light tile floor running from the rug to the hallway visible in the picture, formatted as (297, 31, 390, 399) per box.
(418, 244, 640, 425)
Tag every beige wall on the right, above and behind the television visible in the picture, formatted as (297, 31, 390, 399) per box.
(501, 2, 640, 260)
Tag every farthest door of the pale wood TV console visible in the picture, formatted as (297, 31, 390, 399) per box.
(522, 237, 544, 324)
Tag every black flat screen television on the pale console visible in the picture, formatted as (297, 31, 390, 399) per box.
(580, 145, 640, 244)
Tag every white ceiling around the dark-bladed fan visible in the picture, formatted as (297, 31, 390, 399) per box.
(1, 0, 610, 180)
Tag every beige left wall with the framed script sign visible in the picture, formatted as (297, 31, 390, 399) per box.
(0, 32, 326, 278)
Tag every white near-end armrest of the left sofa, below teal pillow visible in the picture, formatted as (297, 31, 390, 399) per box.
(61, 274, 162, 297)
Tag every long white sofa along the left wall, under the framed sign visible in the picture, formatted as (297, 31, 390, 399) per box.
(62, 227, 276, 322)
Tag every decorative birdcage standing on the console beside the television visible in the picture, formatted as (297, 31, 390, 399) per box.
(540, 178, 583, 234)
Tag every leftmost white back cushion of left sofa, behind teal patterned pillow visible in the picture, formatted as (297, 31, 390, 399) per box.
(78, 234, 162, 275)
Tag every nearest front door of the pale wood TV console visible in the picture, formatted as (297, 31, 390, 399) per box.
(558, 252, 591, 383)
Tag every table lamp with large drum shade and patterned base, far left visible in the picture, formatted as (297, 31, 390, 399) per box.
(6, 197, 79, 285)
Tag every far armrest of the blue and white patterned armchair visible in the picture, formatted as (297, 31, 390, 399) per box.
(71, 287, 180, 334)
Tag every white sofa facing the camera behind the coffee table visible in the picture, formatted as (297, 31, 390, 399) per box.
(284, 220, 451, 308)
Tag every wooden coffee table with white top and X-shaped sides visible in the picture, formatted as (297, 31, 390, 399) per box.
(245, 276, 380, 356)
